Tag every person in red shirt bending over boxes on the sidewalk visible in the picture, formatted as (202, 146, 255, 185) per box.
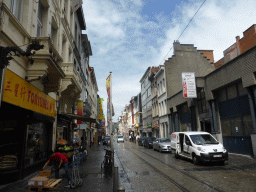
(43, 151, 72, 188)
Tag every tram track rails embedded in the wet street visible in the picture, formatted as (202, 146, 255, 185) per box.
(126, 148, 224, 192)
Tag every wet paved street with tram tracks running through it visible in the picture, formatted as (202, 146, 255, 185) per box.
(115, 141, 256, 192)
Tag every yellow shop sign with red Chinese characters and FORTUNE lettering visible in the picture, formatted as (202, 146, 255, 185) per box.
(3, 69, 56, 117)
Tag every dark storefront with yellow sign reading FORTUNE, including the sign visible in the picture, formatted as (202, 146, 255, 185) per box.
(0, 69, 56, 184)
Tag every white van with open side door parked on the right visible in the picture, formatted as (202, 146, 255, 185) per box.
(171, 131, 228, 165)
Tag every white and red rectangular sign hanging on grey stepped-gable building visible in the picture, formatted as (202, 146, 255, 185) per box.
(181, 72, 197, 98)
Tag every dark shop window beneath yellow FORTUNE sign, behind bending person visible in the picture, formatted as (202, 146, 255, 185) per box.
(25, 123, 48, 166)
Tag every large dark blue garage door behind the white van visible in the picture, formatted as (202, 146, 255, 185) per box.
(217, 81, 252, 155)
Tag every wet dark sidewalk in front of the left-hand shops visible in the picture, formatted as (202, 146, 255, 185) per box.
(0, 144, 113, 192)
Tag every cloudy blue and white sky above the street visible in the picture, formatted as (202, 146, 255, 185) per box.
(83, 0, 256, 121)
